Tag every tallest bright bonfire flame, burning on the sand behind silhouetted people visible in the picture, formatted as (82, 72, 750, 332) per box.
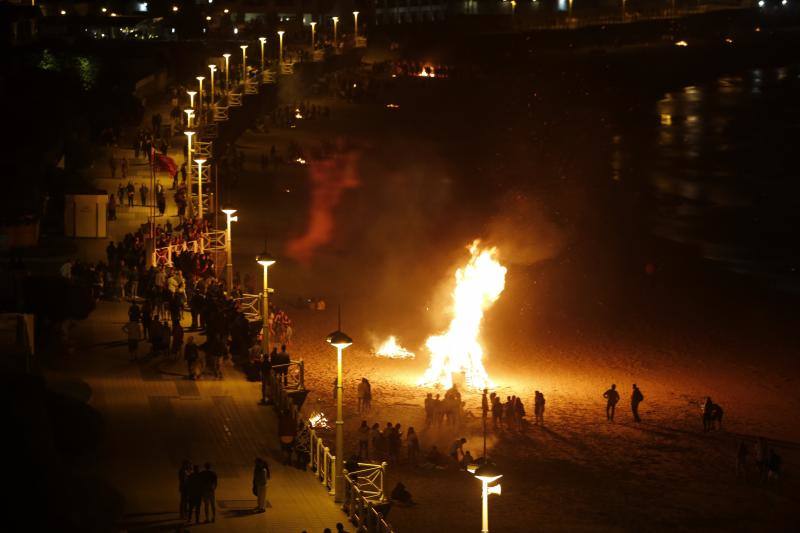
(420, 240, 507, 389)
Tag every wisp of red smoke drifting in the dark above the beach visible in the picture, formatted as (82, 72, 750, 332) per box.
(286, 152, 360, 263)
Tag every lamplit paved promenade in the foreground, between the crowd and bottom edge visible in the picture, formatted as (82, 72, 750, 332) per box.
(49, 302, 345, 533)
